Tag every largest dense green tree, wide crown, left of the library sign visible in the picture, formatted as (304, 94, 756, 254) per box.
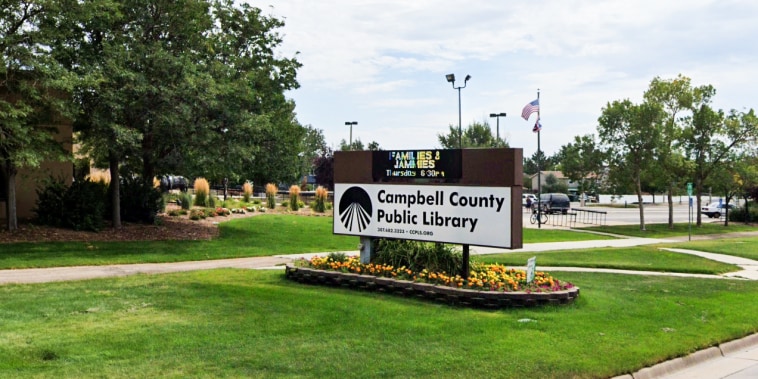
(56, 0, 306, 225)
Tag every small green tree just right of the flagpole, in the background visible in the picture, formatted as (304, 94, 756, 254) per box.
(559, 134, 605, 206)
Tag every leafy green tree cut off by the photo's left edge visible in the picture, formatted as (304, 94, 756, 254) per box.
(0, 0, 65, 230)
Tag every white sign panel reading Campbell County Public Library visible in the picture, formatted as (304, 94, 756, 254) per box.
(334, 183, 511, 248)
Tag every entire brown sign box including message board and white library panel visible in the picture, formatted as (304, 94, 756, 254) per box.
(334, 149, 522, 248)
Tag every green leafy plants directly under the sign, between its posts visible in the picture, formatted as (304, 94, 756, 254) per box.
(373, 239, 463, 274)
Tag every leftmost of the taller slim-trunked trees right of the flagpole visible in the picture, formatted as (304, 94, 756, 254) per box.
(598, 99, 662, 230)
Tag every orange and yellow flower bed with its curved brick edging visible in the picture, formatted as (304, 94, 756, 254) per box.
(285, 257, 579, 309)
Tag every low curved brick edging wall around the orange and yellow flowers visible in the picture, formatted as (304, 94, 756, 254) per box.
(284, 264, 579, 309)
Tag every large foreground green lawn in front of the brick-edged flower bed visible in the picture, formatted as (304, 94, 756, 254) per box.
(0, 269, 758, 378)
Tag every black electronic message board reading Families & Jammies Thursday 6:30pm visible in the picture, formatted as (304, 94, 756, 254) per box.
(372, 150, 461, 181)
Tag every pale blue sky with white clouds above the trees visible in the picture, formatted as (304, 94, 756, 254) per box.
(240, 0, 758, 157)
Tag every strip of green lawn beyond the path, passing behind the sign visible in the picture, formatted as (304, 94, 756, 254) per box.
(0, 215, 610, 269)
